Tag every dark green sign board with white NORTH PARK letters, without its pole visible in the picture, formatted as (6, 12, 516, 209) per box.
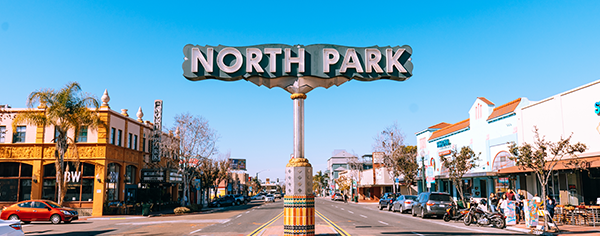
(182, 44, 413, 85)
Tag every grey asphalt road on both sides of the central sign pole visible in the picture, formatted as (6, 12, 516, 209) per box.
(18, 198, 518, 236)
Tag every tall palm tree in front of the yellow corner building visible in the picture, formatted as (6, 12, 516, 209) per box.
(13, 82, 106, 204)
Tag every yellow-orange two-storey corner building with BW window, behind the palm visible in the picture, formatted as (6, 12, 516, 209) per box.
(0, 91, 181, 216)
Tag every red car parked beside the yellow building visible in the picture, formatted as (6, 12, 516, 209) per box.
(0, 200, 79, 224)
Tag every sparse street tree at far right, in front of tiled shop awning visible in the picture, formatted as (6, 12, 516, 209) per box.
(509, 127, 587, 229)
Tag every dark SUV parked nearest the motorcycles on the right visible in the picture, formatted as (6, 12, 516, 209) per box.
(412, 192, 452, 218)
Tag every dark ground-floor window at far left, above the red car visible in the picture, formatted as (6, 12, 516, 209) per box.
(0, 162, 33, 202)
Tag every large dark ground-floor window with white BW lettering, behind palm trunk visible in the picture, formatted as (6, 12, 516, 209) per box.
(42, 162, 96, 202)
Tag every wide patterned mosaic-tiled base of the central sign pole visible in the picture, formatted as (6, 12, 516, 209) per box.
(283, 158, 315, 236)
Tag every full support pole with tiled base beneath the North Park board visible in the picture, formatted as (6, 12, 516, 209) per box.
(283, 93, 315, 236)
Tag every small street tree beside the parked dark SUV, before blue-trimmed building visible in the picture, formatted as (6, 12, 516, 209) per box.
(441, 147, 481, 205)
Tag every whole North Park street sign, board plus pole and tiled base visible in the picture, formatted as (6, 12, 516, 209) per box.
(182, 44, 413, 236)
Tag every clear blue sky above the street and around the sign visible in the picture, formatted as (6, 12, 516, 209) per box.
(0, 1, 600, 182)
